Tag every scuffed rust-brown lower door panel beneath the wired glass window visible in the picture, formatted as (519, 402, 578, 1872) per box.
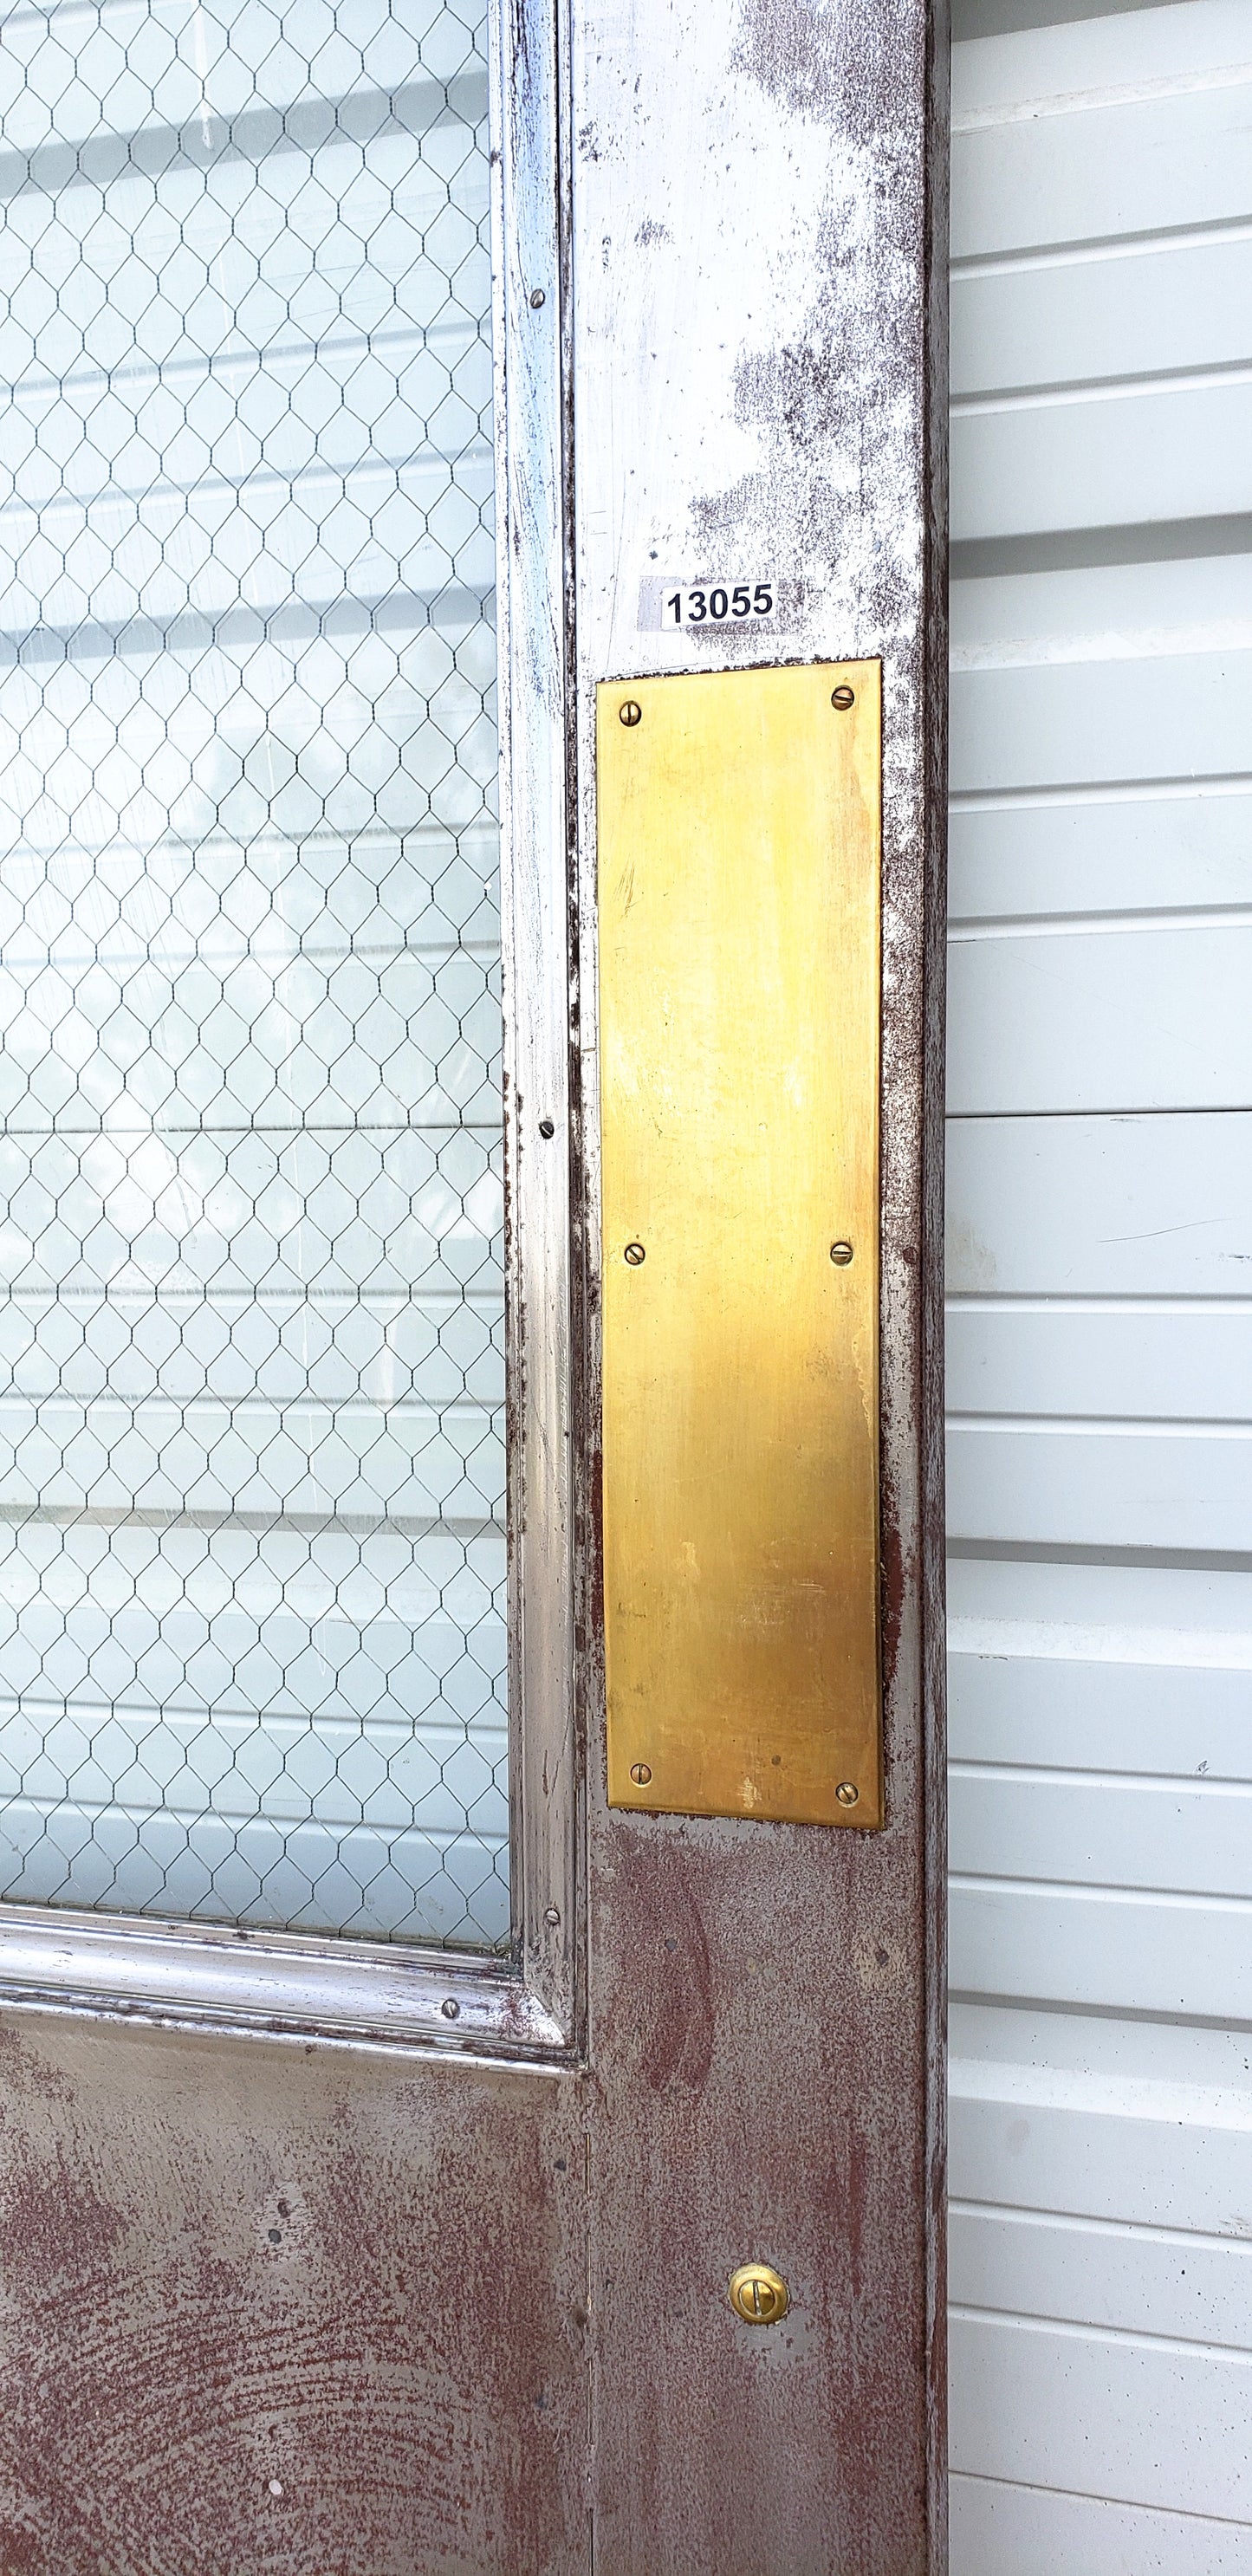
(0, 2017, 587, 2576)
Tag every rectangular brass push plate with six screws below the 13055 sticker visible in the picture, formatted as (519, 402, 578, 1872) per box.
(598, 662, 884, 1827)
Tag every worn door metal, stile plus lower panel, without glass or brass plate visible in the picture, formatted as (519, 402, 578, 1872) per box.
(0, 0, 945, 2576)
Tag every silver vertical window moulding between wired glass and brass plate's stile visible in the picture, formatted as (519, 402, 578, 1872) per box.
(492, 0, 582, 2043)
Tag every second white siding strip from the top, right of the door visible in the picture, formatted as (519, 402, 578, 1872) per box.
(950, 80, 1252, 260)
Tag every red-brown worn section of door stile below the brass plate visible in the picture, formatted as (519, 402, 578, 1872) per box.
(595, 1819, 922, 2576)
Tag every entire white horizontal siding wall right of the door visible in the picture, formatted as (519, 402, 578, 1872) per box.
(948, 0, 1252, 2576)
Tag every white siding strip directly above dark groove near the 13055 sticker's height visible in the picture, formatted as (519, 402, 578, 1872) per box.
(950, 381, 1252, 541)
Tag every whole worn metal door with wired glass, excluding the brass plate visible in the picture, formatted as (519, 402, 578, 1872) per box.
(0, 0, 945, 2576)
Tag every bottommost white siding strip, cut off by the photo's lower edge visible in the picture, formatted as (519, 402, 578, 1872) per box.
(950, 2475, 1252, 2576)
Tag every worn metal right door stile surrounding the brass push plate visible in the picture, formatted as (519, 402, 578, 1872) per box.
(572, 0, 945, 2576)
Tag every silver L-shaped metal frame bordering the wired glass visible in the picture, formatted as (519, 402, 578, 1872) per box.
(0, 0, 582, 2063)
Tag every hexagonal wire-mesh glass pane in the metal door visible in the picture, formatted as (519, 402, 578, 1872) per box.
(0, 0, 508, 1948)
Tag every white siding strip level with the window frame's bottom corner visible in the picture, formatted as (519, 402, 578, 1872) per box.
(950, 1880, 1252, 2019)
